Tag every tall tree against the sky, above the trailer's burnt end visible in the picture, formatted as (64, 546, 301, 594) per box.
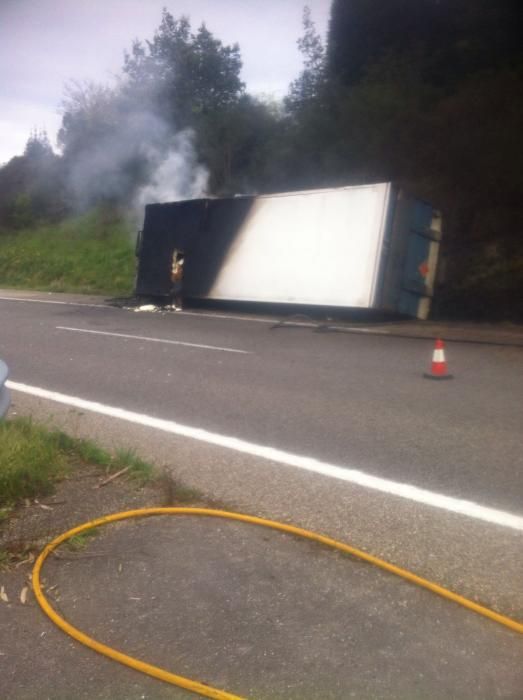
(122, 10, 253, 194)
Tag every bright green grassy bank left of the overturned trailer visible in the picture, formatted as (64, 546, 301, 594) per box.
(0, 209, 135, 296)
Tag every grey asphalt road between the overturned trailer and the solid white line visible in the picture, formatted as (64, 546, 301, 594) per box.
(0, 292, 523, 513)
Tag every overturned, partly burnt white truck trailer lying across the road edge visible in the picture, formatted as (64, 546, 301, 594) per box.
(135, 183, 441, 318)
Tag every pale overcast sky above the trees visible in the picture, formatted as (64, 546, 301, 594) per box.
(0, 0, 331, 164)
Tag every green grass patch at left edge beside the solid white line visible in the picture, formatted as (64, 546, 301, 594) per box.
(0, 418, 153, 513)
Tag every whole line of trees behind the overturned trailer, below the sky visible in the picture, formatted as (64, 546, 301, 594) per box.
(0, 0, 523, 318)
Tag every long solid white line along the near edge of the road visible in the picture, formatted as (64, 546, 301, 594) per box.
(6, 381, 523, 530)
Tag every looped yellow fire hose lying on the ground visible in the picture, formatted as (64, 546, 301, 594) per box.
(33, 508, 523, 700)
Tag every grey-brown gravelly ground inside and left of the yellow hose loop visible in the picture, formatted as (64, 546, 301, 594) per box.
(0, 456, 523, 700)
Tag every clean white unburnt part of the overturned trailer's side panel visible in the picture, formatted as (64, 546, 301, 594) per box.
(208, 184, 390, 307)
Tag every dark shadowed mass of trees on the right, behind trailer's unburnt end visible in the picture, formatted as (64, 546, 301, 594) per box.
(282, 0, 523, 317)
